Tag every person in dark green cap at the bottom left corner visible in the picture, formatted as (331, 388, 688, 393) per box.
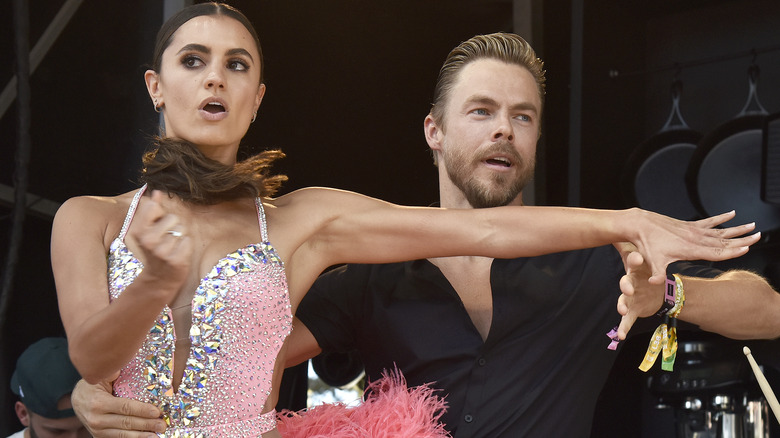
(9, 338, 90, 438)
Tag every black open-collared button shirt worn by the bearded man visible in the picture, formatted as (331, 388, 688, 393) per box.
(297, 246, 623, 438)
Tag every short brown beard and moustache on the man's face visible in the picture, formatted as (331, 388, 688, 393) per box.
(443, 142, 536, 208)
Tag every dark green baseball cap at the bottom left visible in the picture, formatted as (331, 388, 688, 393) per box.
(11, 337, 81, 418)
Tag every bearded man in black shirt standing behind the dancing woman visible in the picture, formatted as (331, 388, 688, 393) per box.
(70, 34, 780, 437)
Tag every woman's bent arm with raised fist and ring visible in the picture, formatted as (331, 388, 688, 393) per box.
(51, 190, 192, 383)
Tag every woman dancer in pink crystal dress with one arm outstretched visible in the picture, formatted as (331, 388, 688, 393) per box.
(52, 4, 758, 438)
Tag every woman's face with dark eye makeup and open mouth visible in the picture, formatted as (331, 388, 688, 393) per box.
(145, 15, 265, 162)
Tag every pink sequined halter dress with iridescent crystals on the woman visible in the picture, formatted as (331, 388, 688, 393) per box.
(108, 186, 292, 438)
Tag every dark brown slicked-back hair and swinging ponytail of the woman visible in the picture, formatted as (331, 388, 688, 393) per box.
(141, 3, 287, 204)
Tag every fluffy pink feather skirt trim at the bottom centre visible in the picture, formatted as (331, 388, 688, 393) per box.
(277, 370, 450, 438)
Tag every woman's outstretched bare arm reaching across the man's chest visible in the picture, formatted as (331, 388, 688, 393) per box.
(280, 189, 760, 288)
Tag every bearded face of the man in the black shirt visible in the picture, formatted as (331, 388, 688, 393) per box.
(437, 59, 541, 208)
